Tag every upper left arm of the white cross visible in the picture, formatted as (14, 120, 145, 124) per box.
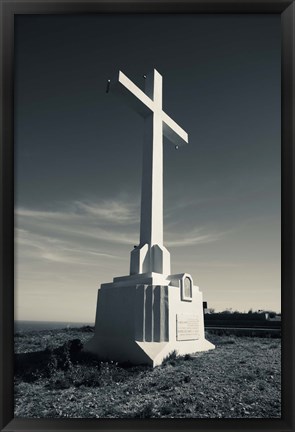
(110, 71, 154, 117)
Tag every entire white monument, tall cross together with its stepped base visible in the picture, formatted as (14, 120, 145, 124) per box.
(85, 69, 214, 366)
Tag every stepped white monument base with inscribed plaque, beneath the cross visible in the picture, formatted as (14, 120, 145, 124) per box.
(84, 273, 215, 367)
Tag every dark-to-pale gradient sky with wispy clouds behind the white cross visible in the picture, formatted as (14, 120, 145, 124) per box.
(15, 14, 281, 323)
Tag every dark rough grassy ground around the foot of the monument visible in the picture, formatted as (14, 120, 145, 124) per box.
(15, 327, 281, 418)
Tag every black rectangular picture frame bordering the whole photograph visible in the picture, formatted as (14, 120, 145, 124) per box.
(0, 0, 295, 432)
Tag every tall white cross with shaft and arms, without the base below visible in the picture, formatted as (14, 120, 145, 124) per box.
(107, 69, 188, 276)
